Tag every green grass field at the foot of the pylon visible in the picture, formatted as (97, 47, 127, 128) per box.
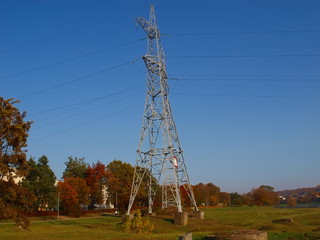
(0, 207, 320, 240)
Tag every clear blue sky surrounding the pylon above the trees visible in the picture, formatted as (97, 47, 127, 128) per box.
(0, 0, 320, 193)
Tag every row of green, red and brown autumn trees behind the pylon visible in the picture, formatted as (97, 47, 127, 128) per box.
(21, 156, 280, 216)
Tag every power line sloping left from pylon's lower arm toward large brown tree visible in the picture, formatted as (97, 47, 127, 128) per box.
(16, 58, 140, 99)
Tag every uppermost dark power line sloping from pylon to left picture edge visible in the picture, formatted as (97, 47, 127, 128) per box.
(0, 39, 144, 79)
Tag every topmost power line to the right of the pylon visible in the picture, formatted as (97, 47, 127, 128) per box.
(161, 29, 320, 37)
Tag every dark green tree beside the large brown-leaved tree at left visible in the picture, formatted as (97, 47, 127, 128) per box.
(22, 155, 56, 211)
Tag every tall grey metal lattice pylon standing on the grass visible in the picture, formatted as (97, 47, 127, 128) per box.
(127, 6, 198, 215)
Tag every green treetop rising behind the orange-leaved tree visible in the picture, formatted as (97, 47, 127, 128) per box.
(63, 156, 88, 178)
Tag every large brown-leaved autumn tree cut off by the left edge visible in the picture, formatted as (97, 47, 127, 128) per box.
(0, 97, 34, 228)
